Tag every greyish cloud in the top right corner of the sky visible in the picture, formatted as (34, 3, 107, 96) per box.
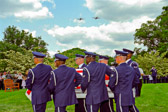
(84, 0, 168, 21)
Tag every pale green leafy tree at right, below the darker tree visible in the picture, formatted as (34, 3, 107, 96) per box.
(135, 51, 168, 76)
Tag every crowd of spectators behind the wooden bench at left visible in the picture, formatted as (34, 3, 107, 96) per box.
(0, 71, 26, 90)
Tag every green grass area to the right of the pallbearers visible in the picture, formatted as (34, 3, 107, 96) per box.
(136, 83, 168, 112)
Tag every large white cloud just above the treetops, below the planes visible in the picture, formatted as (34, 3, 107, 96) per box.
(45, 16, 152, 56)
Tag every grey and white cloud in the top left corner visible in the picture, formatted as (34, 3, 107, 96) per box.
(0, 0, 53, 19)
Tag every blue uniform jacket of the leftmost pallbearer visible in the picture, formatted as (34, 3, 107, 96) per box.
(26, 64, 52, 105)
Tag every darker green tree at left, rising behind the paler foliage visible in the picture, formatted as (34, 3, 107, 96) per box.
(3, 26, 48, 53)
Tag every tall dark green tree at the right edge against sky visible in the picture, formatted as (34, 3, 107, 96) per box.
(134, 6, 168, 53)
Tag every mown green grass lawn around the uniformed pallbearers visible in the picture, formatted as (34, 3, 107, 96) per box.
(0, 83, 168, 112)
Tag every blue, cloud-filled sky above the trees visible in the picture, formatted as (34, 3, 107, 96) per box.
(0, 0, 168, 56)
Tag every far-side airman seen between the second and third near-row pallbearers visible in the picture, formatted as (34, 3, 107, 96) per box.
(75, 54, 86, 112)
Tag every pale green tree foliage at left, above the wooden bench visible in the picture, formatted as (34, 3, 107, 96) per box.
(0, 50, 34, 73)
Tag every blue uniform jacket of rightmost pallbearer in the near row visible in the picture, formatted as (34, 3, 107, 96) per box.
(109, 63, 139, 106)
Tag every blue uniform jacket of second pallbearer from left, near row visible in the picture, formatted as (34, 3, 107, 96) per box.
(48, 65, 82, 107)
